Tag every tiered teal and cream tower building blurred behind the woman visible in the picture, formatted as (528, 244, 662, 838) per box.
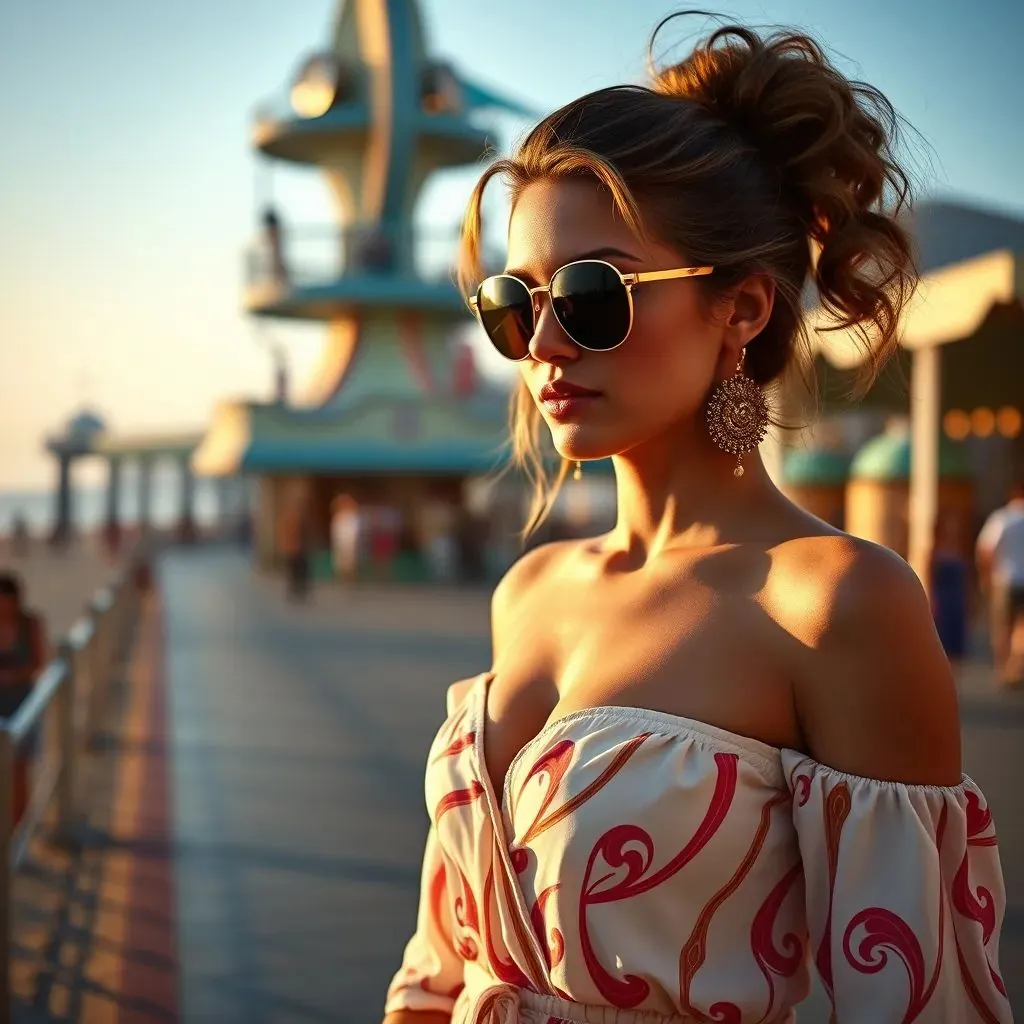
(194, 0, 531, 571)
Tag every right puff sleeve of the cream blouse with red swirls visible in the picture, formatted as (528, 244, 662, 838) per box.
(782, 751, 1013, 1024)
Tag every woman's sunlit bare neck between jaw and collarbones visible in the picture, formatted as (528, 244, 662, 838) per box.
(608, 427, 784, 564)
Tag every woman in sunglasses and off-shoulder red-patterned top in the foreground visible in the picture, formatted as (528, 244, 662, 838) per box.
(385, 18, 1011, 1024)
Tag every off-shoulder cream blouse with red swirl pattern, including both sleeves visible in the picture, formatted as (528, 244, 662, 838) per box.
(387, 671, 1012, 1024)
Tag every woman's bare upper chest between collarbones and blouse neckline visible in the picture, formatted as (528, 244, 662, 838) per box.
(485, 580, 799, 794)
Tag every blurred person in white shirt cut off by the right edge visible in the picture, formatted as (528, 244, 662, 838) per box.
(976, 477, 1024, 685)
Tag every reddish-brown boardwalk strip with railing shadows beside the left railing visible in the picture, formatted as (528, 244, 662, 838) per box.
(12, 598, 178, 1024)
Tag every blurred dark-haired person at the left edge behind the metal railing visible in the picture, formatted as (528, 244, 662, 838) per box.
(0, 572, 47, 825)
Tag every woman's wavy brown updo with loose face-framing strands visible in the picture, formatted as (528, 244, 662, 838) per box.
(459, 11, 916, 537)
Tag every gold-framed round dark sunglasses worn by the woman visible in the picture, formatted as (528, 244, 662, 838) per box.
(469, 259, 714, 362)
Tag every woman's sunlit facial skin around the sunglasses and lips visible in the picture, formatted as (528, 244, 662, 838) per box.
(508, 179, 738, 460)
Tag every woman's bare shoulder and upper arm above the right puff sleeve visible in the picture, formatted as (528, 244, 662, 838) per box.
(770, 531, 961, 785)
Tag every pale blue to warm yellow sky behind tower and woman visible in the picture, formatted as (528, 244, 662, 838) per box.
(0, 0, 1024, 487)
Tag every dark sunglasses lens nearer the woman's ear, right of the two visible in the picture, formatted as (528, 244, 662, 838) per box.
(551, 261, 630, 351)
